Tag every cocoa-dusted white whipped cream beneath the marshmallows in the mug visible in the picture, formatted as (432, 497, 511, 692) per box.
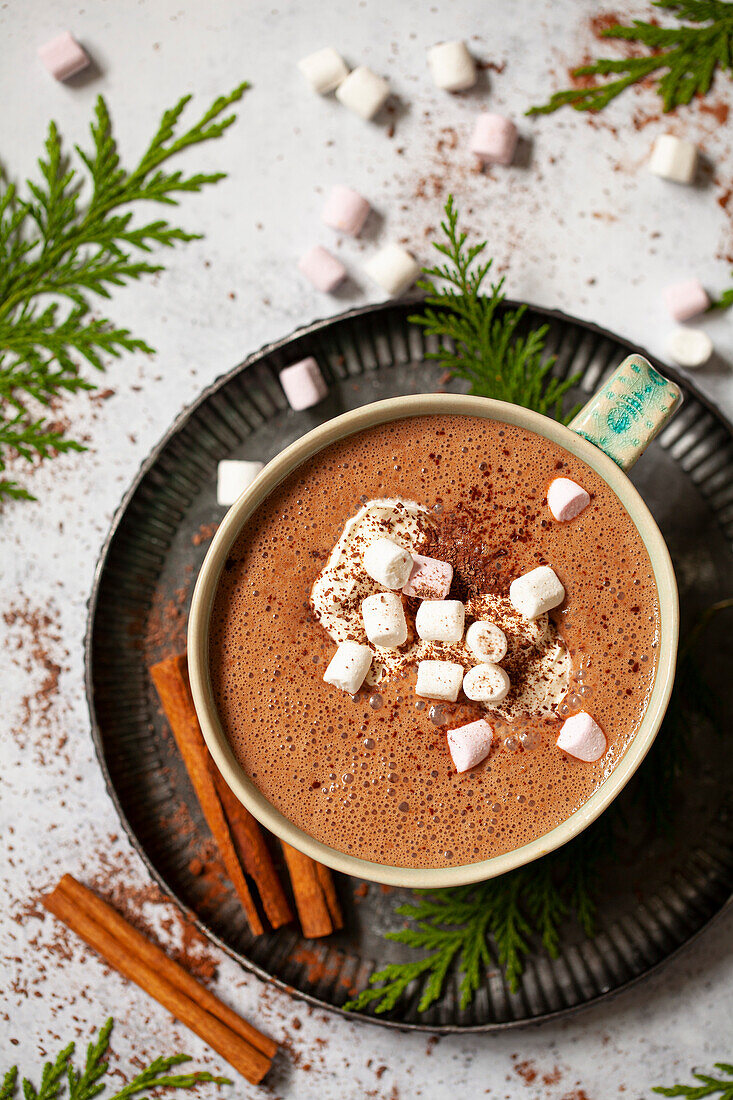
(310, 498, 571, 722)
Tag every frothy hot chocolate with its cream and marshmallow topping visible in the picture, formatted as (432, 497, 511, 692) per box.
(210, 416, 659, 867)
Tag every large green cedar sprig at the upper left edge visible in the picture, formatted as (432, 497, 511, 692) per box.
(0, 84, 248, 501)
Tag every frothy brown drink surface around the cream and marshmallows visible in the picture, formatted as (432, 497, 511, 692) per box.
(210, 416, 659, 867)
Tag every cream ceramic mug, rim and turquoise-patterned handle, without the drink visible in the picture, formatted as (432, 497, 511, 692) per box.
(188, 355, 680, 889)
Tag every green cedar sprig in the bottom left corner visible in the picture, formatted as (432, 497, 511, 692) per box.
(0, 1016, 232, 1100)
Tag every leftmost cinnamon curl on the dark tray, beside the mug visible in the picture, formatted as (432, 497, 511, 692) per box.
(150, 656, 264, 936)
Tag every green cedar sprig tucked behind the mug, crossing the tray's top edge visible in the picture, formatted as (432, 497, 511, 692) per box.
(409, 195, 578, 420)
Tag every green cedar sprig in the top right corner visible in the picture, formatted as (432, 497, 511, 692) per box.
(526, 0, 733, 114)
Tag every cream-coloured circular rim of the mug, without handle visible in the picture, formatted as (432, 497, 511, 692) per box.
(187, 394, 679, 889)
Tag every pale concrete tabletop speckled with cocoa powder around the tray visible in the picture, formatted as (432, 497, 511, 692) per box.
(0, 0, 733, 1100)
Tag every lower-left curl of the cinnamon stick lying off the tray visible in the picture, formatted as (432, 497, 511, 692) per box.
(43, 888, 272, 1085)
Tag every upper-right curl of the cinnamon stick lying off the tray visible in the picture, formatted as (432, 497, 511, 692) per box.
(56, 875, 277, 1058)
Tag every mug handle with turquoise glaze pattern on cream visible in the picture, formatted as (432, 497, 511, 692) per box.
(569, 355, 682, 470)
